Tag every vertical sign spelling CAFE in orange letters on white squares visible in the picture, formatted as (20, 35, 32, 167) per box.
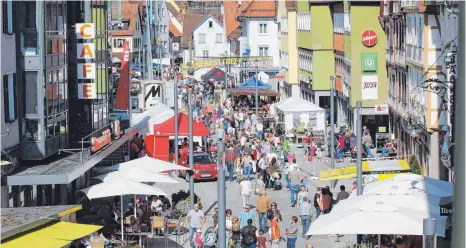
(75, 23, 97, 99)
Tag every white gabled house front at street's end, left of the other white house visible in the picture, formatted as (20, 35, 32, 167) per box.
(193, 16, 230, 58)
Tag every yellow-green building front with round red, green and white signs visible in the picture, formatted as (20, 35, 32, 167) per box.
(345, 2, 389, 145)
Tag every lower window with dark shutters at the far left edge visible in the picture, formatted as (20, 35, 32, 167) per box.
(2, 74, 17, 123)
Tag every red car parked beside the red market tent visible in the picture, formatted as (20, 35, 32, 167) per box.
(178, 152, 217, 181)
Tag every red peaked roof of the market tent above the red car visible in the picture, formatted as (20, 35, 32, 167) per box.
(154, 113, 209, 136)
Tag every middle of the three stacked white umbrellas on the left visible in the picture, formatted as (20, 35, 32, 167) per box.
(94, 167, 178, 183)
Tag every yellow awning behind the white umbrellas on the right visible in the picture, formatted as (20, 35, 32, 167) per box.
(319, 160, 411, 180)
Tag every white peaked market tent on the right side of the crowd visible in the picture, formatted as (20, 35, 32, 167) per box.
(275, 97, 325, 131)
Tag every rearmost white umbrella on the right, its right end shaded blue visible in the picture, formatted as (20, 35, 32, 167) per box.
(351, 174, 453, 197)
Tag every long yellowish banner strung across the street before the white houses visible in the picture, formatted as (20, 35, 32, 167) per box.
(194, 56, 273, 69)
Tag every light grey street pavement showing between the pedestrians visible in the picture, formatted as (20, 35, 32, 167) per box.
(151, 146, 356, 248)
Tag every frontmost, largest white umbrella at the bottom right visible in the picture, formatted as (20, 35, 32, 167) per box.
(306, 201, 446, 236)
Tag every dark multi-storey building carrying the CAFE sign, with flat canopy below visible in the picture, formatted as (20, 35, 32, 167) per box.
(1, 1, 111, 207)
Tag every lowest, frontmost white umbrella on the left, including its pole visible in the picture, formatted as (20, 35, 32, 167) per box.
(80, 178, 167, 240)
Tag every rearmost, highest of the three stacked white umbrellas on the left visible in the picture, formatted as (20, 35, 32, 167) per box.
(109, 156, 191, 173)
